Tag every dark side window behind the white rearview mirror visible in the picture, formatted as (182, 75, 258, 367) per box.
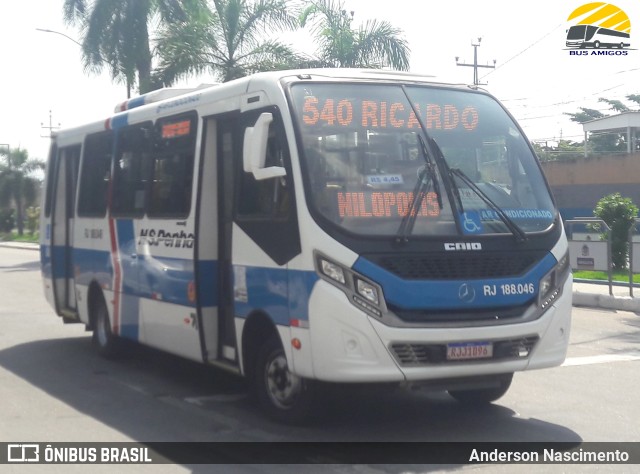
(237, 117, 291, 220)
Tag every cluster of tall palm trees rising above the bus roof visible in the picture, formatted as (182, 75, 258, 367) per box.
(63, 0, 409, 90)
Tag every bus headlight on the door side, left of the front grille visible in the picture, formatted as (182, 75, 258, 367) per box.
(315, 252, 386, 318)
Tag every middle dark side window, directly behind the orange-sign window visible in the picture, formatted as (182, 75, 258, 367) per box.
(111, 122, 153, 217)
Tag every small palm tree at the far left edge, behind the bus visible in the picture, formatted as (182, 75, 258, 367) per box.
(0, 148, 44, 235)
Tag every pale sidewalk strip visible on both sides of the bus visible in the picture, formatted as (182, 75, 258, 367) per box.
(0, 242, 640, 313)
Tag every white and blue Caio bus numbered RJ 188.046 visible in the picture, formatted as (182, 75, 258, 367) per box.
(41, 69, 572, 422)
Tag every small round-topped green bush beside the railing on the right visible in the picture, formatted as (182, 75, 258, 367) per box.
(593, 193, 638, 270)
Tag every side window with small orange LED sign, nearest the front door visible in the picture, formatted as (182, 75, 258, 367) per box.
(148, 114, 197, 217)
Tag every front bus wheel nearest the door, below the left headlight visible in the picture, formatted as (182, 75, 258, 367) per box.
(254, 335, 316, 424)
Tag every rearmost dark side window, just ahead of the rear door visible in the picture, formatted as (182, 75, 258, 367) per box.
(78, 131, 113, 217)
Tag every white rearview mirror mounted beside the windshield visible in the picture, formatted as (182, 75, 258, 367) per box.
(242, 112, 287, 181)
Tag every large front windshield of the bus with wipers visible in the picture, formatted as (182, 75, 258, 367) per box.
(291, 83, 555, 237)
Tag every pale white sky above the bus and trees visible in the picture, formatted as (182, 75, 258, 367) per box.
(0, 0, 640, 159)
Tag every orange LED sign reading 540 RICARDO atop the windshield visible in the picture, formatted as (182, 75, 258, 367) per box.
(302, 96, 479, 131)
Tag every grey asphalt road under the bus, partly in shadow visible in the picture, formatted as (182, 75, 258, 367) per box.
(0, 248, 640, 473)
